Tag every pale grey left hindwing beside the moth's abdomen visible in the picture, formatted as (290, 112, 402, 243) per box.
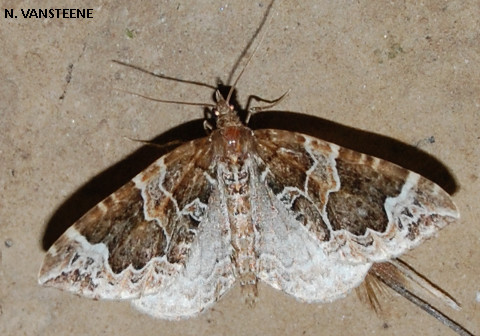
(132, 190, 235, 319)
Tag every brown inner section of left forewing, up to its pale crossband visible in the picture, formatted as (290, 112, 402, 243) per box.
(141, 138, 216, 263)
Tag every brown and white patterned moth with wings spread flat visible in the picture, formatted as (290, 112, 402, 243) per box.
(38, 8, 472, 336)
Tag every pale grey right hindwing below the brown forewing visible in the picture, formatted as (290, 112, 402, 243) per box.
(252, 187, 371, 302)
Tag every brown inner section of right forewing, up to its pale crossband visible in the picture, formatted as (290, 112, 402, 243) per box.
(254, 130, 338, 241)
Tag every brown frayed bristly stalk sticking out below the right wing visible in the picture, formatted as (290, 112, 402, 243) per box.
(368, 260, 474, 336)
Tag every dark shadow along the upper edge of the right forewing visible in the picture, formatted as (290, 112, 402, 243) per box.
(250, 111, 458, 194)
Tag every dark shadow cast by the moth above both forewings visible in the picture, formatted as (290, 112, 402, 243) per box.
(42, 111, 457, 250)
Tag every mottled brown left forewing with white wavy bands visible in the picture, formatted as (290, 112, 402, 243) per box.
(39, 138, 215, 299)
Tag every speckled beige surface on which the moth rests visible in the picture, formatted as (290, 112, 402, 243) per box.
(0, 0, 480, 336)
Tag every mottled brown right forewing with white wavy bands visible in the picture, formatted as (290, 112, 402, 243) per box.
(254, 130, 459, 263)
